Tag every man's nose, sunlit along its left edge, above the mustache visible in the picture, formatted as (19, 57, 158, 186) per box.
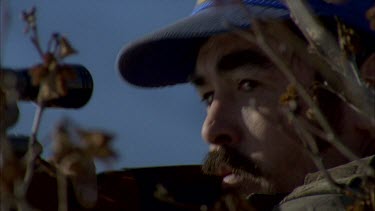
(202, 100, 241, 145)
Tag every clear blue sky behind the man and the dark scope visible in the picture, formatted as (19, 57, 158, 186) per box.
(1, 0, 207, 171)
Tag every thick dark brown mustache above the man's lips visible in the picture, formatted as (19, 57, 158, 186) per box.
(202, 148, 263, 177)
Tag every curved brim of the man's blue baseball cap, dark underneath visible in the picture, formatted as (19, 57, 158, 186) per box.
(117, 5, 288, 87)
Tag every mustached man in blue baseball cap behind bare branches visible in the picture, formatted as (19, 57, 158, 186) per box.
(118, 0, 375, 210)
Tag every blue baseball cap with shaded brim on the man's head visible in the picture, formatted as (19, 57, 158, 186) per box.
(117, 0, 375, 87)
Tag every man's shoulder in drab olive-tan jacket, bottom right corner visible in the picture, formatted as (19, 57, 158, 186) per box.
(274, 155, 375, 211)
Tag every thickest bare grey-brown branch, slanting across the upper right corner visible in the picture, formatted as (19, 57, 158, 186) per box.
(284, 0, 375, 121)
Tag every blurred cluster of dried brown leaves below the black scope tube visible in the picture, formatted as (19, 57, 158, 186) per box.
(52, 121, 115, 207)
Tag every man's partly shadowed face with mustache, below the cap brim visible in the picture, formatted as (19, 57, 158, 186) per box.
(192, 34, 315, 194)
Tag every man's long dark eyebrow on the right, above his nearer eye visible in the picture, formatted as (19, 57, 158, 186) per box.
(216, 49, 272, 72)
